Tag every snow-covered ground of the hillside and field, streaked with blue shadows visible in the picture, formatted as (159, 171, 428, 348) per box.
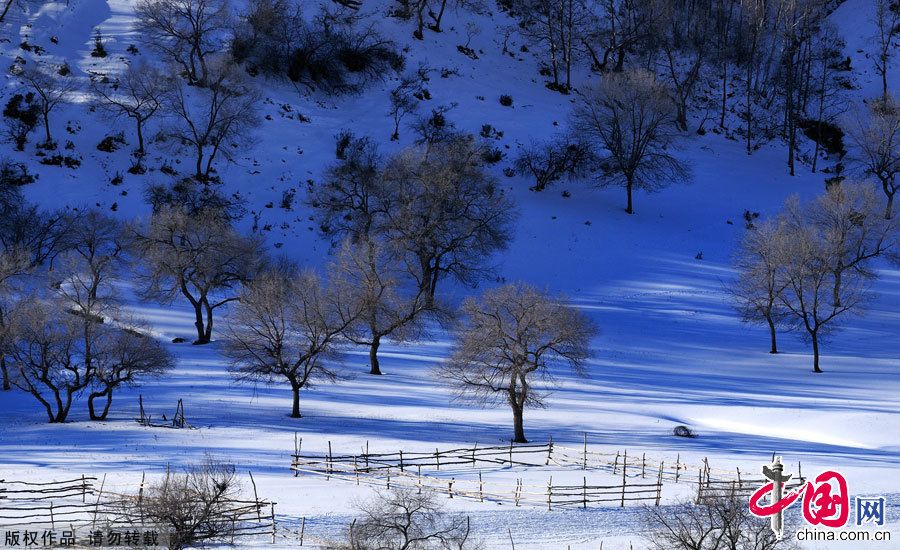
(0, 0, 900, 548)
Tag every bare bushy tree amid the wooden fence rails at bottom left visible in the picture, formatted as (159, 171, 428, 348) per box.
(134, 460, 241, 550)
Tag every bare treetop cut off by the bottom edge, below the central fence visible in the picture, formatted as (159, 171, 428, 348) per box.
(343, 488, 482, 550)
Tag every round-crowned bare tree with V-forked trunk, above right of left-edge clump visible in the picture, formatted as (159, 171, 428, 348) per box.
(133, 209, 263, 344)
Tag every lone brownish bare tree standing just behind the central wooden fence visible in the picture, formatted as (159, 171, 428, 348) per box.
(437, 283, 597, 443)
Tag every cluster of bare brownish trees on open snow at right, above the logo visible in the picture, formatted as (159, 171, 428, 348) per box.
(731, 182, 900, 373)
